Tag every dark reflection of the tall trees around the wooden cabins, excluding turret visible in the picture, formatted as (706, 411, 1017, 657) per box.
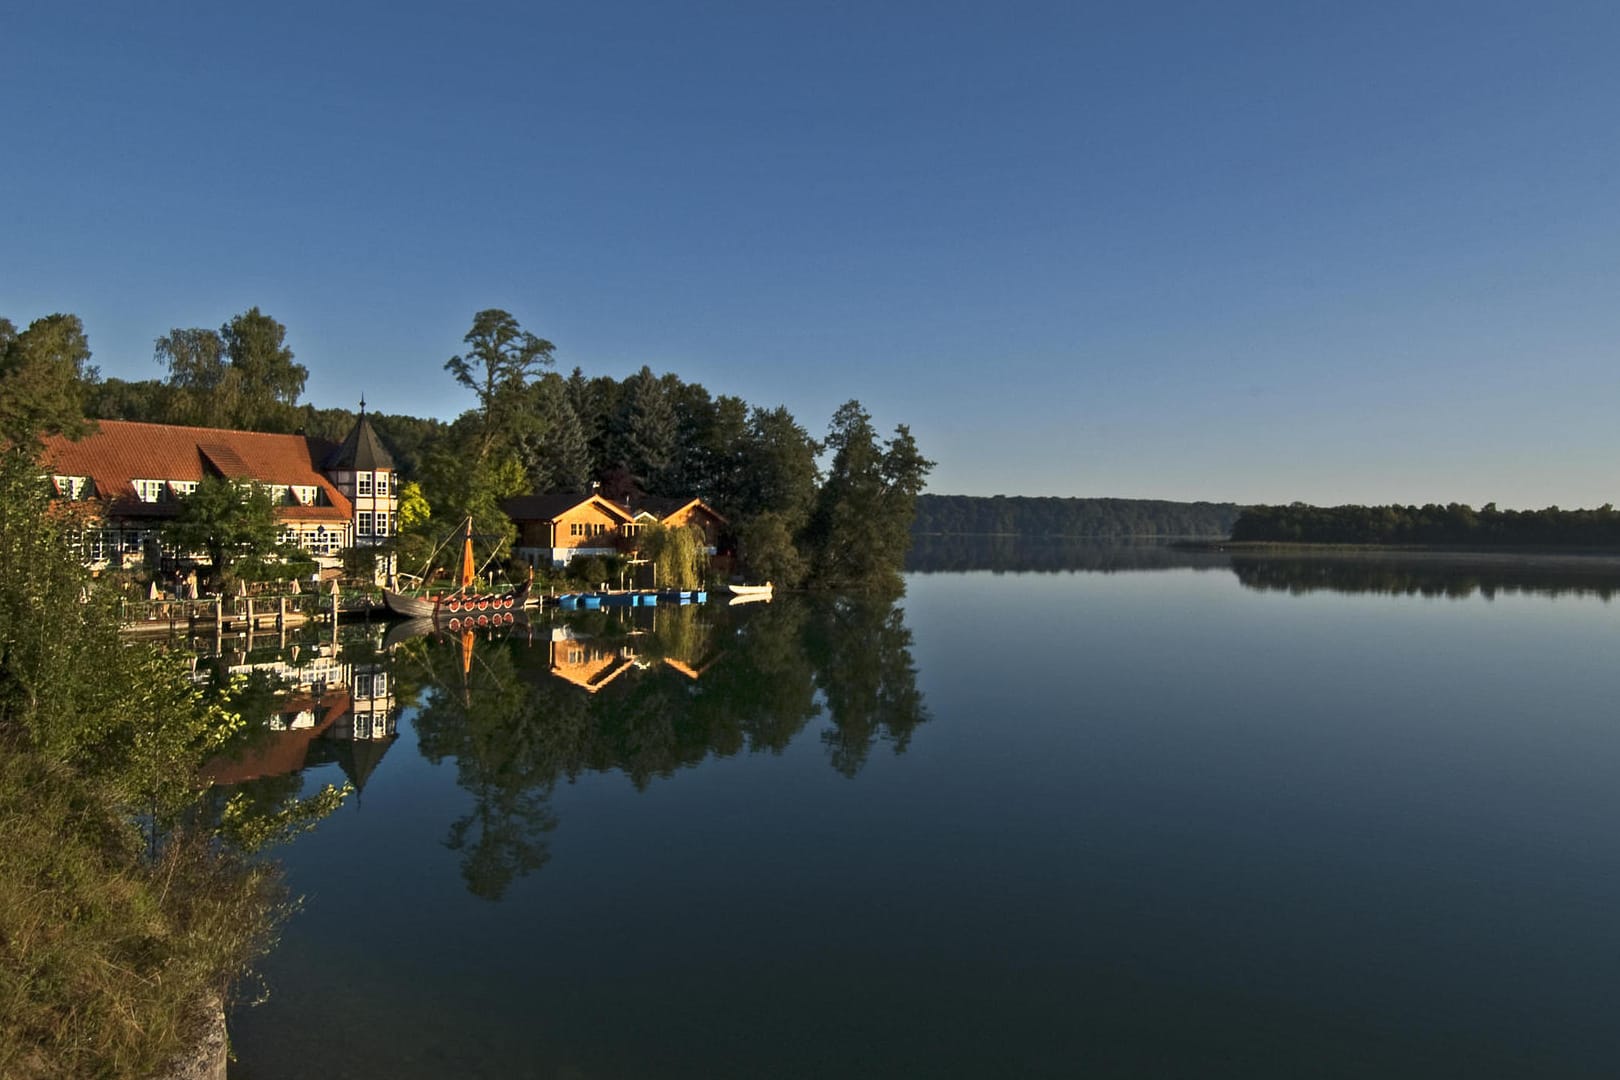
(405, 597, 927, 900)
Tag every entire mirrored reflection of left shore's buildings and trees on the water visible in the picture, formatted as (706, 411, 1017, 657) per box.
(203, 597, 928, 900)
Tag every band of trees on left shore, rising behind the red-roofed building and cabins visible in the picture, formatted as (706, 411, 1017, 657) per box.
(0, 308, 933, 589)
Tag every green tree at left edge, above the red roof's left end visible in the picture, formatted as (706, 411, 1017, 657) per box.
(0, 314, 96, 447)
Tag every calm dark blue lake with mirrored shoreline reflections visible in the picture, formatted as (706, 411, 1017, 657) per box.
(221, 546, 1620, 1080)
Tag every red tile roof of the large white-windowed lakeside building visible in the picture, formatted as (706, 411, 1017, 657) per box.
(45, 419, 353, 521)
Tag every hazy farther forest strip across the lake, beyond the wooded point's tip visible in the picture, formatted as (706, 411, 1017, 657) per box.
(912, 495, 1239, 539)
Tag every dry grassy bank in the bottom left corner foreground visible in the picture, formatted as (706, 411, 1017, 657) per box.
(0, 746, 285, 1080)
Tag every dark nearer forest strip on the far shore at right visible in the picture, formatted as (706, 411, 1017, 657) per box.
(1231, 502, 1620, 547)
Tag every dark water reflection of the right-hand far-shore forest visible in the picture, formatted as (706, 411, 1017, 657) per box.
(1231, 552, 1620, 601)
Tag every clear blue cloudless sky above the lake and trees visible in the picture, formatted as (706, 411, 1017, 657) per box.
(0, 0, 1620, 507)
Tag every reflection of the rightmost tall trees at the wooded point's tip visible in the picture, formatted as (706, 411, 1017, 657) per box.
(805, 597, 928, 777)
